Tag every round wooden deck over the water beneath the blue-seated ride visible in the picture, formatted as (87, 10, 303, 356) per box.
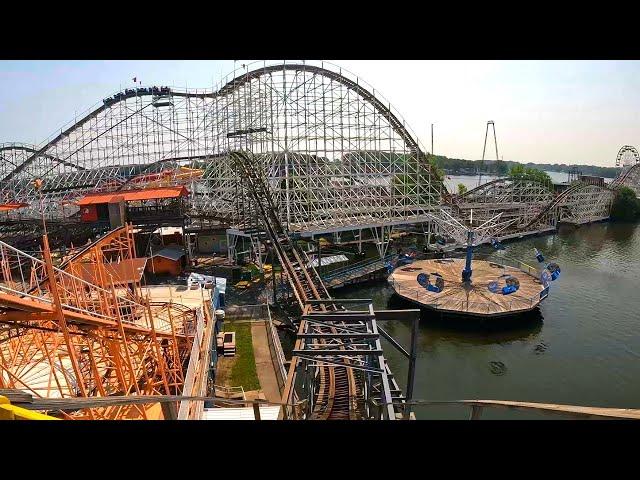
(389, 258, 548, 316)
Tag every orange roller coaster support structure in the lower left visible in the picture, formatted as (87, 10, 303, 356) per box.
(0, 225, 202, 419)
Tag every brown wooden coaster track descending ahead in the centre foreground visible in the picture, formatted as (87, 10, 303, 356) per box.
(230, 152, 399, 420)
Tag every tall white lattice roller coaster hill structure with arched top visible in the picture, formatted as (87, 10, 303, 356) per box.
(0, 62, 444, 232)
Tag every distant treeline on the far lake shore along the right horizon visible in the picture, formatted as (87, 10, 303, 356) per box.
(434, 155, 620, 178)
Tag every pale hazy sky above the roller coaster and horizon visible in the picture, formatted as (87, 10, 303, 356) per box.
(0, 60, 640, 166)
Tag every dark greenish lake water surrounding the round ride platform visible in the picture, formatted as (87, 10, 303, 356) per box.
(334, 223, 640, 419)
